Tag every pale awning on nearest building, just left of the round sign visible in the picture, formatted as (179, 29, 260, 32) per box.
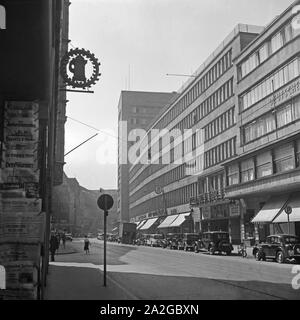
(251, 195, 288, 223)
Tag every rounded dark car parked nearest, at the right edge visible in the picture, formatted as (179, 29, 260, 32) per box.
(252, 234, 300, 263)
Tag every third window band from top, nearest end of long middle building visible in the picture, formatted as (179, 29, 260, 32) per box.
(204, 107, 236, 141)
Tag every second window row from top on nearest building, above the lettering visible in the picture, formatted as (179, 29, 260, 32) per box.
(239, 57, 300, 111)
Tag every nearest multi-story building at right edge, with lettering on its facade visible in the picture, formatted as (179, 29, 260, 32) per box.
(225, 1, 300, 239)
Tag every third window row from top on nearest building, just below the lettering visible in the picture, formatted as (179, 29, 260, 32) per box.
(241, 96, 300, 144)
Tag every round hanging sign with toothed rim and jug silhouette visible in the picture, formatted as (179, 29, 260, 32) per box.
(60, 48, 101, 89)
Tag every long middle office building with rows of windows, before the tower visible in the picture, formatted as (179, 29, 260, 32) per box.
(129, 24, 262, 240)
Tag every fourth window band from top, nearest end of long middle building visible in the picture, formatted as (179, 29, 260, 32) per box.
(204, 137, 236, 169)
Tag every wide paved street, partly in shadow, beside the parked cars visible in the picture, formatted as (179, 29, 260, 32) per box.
(47, 239, 300, 300)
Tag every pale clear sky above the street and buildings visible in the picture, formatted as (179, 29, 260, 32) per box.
(65, 0, 293, 190)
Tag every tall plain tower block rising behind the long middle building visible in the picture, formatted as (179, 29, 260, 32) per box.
(117, 91, 176, 222)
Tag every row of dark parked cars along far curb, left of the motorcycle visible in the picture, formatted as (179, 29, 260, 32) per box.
(135, 231, 233, 255)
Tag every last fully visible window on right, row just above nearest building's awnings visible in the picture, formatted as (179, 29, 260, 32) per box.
(274, 143, 295, 173)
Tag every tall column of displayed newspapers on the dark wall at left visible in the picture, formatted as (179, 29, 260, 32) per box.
(0, 101, 45, 299)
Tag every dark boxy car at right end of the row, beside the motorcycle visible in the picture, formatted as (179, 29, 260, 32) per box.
(201, 231, 233, 255)
